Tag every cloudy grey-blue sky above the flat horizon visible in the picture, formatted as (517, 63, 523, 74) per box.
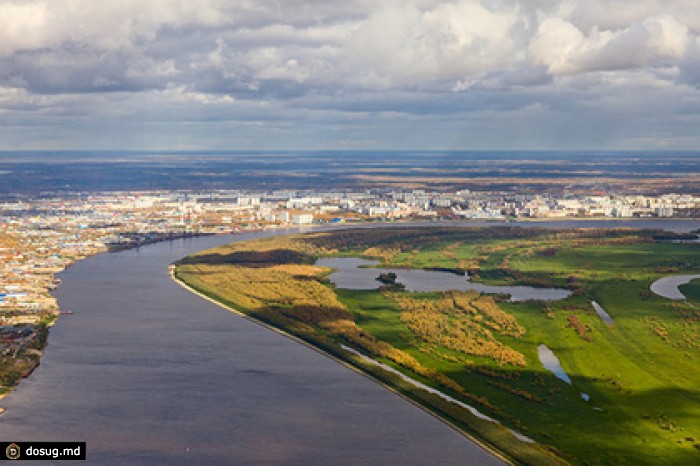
(0, 0, 700, 150)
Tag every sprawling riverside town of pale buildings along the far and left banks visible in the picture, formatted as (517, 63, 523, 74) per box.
(0, 186, 700, 404)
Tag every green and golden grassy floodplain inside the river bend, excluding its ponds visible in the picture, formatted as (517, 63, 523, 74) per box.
(175, 227, 700, 465)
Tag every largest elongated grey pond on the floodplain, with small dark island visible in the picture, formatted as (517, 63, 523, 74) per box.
(316, 257, 571, 301)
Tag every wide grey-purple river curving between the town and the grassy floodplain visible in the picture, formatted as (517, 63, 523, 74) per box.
(0, 233, 502, 465)
